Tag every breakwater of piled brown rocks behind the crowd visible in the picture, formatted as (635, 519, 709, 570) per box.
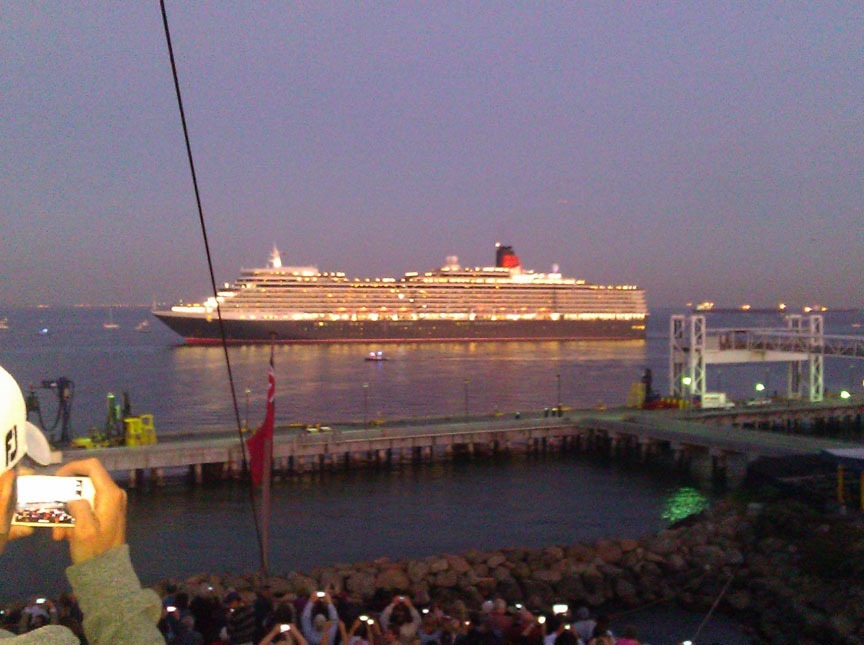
(163, 502, 864, 643)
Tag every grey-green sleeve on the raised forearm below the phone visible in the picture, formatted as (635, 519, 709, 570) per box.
(66, 544, 165, 645)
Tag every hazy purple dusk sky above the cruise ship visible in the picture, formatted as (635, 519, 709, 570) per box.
(0, 0, 864, 307)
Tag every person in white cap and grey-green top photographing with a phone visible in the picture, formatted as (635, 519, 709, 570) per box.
(0, 368, 165, 645)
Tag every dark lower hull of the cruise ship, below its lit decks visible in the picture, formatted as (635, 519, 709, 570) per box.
(154, 311, 647, 344)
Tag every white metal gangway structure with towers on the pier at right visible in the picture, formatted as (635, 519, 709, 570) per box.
(669, 314, 864, 402)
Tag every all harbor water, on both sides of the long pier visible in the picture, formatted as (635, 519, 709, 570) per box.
(0, 308, 864, 642)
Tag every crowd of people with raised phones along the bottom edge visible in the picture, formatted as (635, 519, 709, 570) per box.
(5, 584, 640, 645)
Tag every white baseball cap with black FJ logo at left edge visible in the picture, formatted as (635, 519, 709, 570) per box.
(0, 367, 51, 474)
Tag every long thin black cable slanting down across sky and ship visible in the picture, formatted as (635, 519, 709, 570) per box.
(159, 0, 267, 568)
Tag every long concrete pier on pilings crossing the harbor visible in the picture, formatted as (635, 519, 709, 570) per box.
(62, 401, 864, 487)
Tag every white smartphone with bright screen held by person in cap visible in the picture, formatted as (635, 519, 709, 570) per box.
(12, 475, 96, 527)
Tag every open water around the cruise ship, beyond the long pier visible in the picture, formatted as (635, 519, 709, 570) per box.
(0, 307, 864, 435)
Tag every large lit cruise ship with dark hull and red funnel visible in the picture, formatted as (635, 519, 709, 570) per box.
(153, 244, 648, 344)
